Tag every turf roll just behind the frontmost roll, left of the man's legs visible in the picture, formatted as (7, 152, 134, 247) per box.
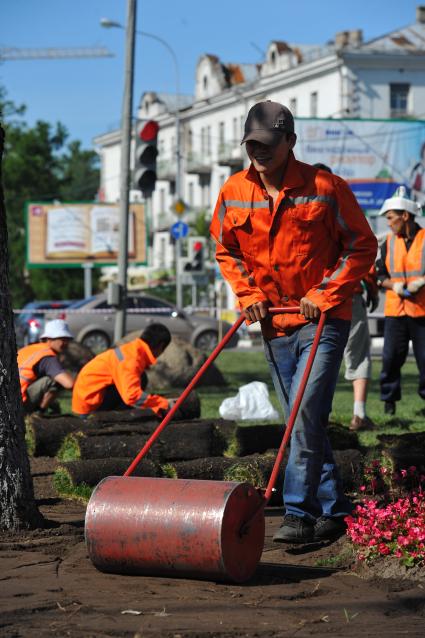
(58, 421, 226, 462)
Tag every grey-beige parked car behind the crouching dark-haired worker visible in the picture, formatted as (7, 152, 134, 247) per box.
(51, 293, 239, 353)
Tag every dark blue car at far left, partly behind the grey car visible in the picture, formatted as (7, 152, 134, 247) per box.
(15, 299, 75, 348)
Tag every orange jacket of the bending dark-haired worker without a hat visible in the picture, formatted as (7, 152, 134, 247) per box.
(72, 339, 168, 414)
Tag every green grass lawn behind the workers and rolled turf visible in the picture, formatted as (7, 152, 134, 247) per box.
(61, 350, 425, 446)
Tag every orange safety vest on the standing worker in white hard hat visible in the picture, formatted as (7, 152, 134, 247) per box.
(384, 228, 425, 317)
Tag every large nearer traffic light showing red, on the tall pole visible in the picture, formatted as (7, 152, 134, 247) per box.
(133, 120, 159, 197)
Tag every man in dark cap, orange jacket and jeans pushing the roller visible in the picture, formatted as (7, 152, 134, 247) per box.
(211, 101, 377, 543)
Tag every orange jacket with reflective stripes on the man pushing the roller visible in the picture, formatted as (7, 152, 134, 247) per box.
(211, 152, 377, 339)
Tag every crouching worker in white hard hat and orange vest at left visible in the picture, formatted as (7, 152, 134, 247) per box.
(18, 319, 74, 413)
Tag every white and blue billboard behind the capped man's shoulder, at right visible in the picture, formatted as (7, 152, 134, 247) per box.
(295, 118, 425, 211)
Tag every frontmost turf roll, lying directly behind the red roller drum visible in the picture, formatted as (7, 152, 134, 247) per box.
(53, 458, 162, 496)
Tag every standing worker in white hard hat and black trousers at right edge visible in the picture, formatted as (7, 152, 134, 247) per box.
(376, 186, 425, 415)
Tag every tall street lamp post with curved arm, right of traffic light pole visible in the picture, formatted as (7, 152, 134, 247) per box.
(100, 18, 183, 307)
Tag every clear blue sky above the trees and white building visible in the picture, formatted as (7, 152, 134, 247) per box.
(0, 0, 420, 148)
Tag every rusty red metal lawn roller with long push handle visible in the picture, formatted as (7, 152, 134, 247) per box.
(85, 306, 325, 583)
